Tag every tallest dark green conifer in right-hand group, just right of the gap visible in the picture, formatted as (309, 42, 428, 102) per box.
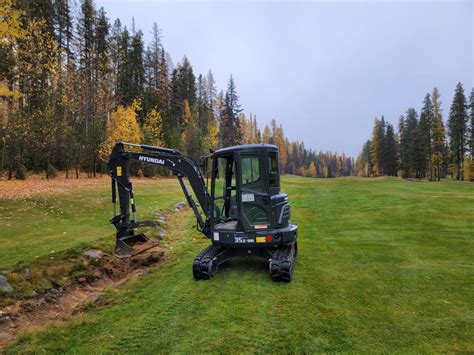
(448, 83, 468, 180)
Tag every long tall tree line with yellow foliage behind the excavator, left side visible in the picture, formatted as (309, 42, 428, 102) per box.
(0, 0, 355, 179)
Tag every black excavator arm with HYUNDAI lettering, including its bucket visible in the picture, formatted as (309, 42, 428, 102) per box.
(107, 142, 210, 256)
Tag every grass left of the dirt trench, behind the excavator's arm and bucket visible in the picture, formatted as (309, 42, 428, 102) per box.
(0, 179, 185, 269)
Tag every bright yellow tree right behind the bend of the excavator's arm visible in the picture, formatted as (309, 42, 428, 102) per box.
(99, 100, 142, 161)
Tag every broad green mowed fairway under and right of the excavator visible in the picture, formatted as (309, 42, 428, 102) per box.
(2, 177, 474, 353)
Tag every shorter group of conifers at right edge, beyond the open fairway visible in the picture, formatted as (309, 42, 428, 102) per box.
(356, 83, 474, 181)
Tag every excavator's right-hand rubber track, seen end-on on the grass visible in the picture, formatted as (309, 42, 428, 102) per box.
(269, 242, 298, 282)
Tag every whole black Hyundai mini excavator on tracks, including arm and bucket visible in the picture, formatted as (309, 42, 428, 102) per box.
(108, 142, 298, 282)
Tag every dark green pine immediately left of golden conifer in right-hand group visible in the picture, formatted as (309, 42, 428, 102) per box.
(419, 93, 434, 179)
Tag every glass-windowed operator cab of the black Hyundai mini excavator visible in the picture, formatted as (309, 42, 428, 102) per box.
(211, 144, 290, 232)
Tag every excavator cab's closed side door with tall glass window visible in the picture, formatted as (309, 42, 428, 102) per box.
(239, 153, 271, 230)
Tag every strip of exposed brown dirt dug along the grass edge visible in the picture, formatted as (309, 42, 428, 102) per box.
(0, 248, 167, 351)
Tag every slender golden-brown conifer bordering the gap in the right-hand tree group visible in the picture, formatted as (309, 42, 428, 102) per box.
(431, 88, 446, 181)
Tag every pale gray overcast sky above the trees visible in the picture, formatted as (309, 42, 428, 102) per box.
(96, 0, 474, 155)
